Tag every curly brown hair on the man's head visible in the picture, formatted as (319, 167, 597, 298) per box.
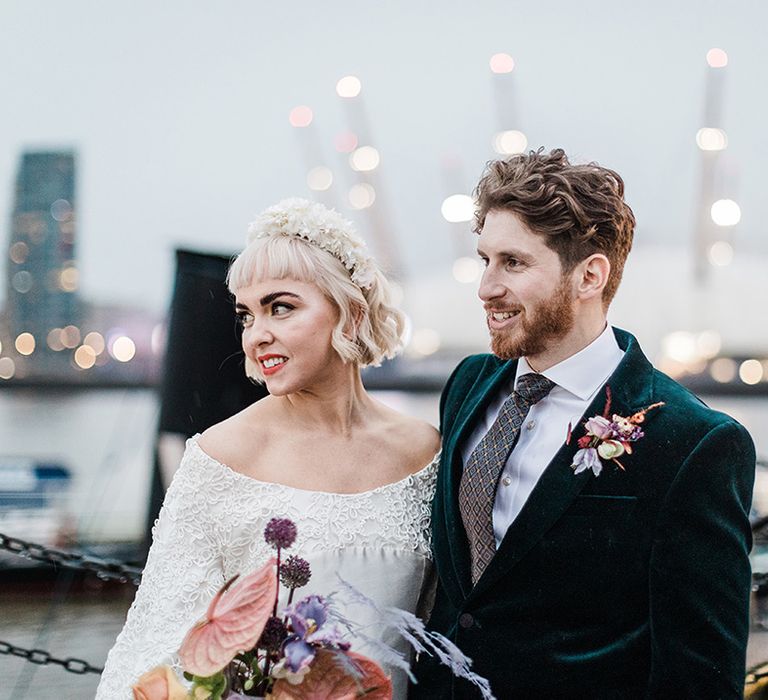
(474, 148, 635, 307)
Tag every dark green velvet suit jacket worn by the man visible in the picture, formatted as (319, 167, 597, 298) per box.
(410, 329, 755, 700)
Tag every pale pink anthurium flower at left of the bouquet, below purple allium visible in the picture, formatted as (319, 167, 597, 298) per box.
(179, 559, 277, 677)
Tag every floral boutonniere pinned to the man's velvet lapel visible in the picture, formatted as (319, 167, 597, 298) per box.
(566, 385, 664, 476)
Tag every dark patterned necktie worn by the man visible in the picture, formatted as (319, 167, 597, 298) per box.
(459, 374, 555, 585)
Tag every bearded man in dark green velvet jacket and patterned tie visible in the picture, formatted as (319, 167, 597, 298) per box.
(411, 150, 755, 700)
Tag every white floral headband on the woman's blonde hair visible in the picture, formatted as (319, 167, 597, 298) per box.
(248, 197, 374, 289)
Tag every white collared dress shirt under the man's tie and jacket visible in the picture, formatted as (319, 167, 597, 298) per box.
(462, 326, 624, 547)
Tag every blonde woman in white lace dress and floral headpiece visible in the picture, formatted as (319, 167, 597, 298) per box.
(96, 199, 439, 700)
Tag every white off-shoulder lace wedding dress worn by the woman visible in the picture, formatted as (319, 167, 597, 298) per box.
(96, 436, 438, 700)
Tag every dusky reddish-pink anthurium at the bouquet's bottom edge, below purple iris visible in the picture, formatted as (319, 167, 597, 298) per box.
(268, 649, 392, 700)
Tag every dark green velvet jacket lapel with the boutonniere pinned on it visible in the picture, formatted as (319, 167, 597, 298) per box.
(467, 329, 653, 597)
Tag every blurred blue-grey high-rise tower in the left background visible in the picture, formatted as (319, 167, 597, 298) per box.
(6, 151, 80, 374)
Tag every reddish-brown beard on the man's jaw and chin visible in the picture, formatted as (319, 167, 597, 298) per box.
(491, 279, 574, 360)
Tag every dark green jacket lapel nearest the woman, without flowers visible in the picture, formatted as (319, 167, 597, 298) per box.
(442, 357, 517, 605)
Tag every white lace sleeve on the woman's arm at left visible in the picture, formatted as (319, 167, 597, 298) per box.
(96, 444, 227, 700)
